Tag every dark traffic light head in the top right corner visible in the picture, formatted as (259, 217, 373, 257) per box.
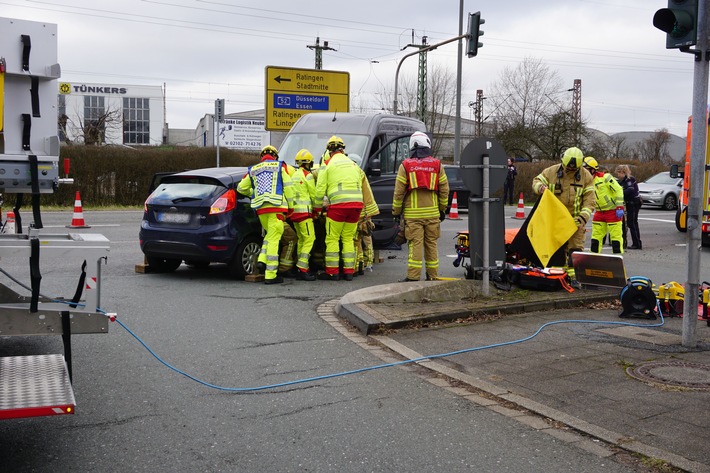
(653, 0, 698, 49)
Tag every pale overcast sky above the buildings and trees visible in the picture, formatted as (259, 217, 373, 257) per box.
(0, 0, 693, 137)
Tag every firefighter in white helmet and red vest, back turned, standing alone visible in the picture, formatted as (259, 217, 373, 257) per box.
(392, 131, 449, 281)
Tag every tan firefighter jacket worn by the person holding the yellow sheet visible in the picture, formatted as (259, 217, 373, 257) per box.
(532, 164, 596, 223)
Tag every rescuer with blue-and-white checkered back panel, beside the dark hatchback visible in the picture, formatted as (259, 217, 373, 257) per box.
(237, 146, 293, 284)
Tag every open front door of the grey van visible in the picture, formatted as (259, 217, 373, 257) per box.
(365, 134, 410, 249)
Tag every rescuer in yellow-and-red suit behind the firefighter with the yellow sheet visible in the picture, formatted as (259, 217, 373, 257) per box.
(584, 156, 624, 254)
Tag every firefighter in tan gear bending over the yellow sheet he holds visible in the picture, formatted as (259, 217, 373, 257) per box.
(532, 147, 596, 262)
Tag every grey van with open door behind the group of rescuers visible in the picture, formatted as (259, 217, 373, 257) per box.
(279, 112, 426, 249)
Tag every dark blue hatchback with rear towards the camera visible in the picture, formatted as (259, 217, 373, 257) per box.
(139, 167, 262, 278)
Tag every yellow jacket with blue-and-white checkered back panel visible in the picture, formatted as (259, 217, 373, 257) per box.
(237, 156, 293, 214)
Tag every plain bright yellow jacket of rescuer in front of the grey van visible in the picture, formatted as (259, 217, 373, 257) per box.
(313, 153, 365, 209)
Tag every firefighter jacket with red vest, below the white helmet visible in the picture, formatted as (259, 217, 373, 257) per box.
(392, 156, 449, 219)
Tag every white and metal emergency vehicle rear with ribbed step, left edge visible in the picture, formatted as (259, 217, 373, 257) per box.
(0, 18, 109, 419)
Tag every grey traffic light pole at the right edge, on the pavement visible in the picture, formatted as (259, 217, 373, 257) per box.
(681, 0, 710, 348)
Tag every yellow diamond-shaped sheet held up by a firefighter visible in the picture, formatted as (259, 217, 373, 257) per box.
(527, 189, 577, 267)
